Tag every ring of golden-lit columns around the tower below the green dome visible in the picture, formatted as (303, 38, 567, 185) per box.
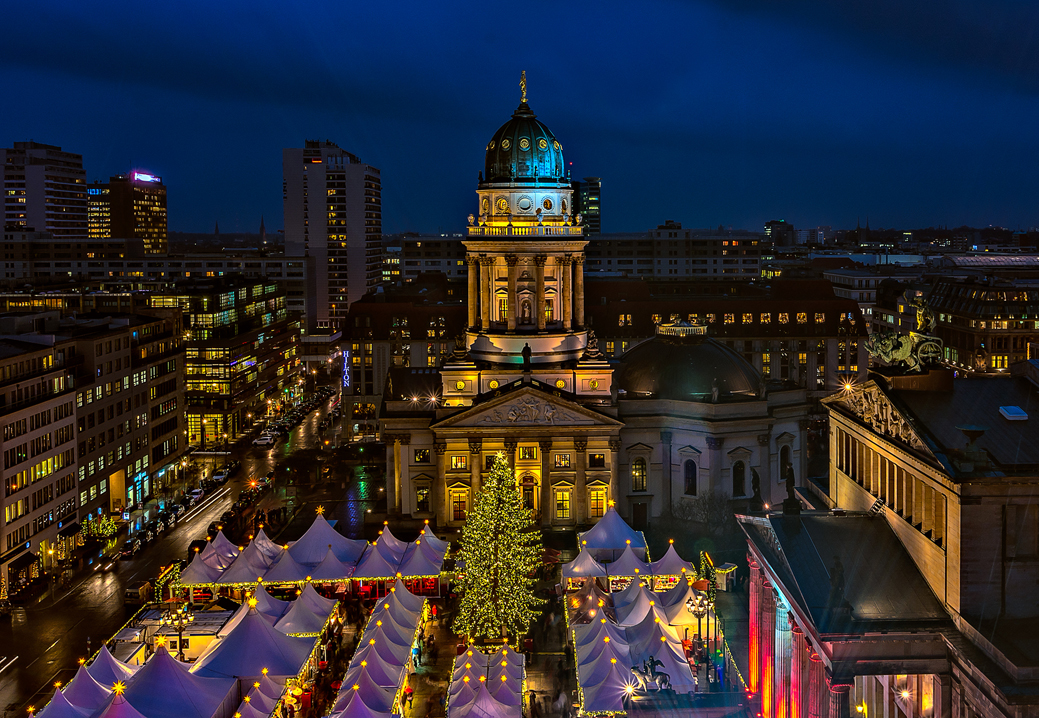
(465, 254, 585, 331)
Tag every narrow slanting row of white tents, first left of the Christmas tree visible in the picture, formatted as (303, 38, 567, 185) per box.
(329, 577, 426, 718)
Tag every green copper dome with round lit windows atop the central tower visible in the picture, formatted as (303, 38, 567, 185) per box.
(483, 101, 569, 184)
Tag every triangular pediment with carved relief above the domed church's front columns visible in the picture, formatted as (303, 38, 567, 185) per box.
(430, 387, 623, 431)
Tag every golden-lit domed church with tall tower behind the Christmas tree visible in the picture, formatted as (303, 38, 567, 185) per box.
(379, 79, 809, 529)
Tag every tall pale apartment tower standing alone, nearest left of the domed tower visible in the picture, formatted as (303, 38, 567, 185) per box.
(282, 140, 382, 333)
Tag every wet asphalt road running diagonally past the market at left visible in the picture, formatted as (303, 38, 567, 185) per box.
(0, 402, 330, 718)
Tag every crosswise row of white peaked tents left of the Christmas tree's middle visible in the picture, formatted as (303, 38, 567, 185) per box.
(179, 514, 448, 587)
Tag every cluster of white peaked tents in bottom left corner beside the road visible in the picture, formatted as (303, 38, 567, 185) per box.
(37, 585, 337, 718)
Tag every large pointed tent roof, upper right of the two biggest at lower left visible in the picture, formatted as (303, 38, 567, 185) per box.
(191, 609, 315, 677)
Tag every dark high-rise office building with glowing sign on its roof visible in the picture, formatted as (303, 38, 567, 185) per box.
(87, 171, 168, 255)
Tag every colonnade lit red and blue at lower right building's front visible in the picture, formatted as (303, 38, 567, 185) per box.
(749, 559, 852, 718)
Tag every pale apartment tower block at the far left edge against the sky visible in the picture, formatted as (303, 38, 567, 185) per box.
(0, 142, 87, 240)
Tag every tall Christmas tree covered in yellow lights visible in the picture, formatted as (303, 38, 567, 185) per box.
(454, 453, 543, 643)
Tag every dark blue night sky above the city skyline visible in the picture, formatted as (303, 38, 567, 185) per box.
(0, 0, 1039, 232)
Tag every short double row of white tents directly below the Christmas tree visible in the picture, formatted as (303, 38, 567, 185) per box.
(447, 646, 526, 718)
